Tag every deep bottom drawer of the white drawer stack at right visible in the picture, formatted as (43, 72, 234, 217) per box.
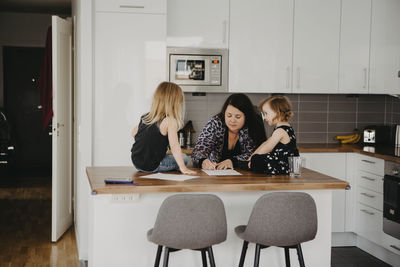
(356, 203, 384, 245)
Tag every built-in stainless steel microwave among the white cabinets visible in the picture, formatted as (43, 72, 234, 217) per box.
(167, 47, 228, 93)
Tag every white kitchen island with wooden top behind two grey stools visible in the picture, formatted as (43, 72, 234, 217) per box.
(87, 167, 349, 267)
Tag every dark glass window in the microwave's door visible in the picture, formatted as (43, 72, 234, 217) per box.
(175, 59, 205, 81)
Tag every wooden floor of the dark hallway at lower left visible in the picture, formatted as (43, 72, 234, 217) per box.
(0, 169, 79, 267)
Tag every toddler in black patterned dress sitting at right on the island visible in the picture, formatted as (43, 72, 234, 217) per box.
(249, 95, 299, 174)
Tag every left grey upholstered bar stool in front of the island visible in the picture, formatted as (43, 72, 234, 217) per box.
(147, 194, 227, 267)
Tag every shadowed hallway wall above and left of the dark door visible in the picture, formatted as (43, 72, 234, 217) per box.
(0, 12, 51, 107)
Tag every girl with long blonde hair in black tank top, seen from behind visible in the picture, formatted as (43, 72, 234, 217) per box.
(131, 82, 196, 174)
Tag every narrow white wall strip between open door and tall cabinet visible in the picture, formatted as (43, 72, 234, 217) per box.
(72, 0, 93, 260)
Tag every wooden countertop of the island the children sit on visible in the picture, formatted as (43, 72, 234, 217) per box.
(86, 167, 349, 194)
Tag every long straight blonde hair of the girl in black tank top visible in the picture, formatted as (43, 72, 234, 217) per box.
(142, 82, 185, 129)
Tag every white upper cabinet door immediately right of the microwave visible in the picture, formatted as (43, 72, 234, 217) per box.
(229, 0, 293, 93)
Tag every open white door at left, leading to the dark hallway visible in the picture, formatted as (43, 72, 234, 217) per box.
(51, 16, 73, 242)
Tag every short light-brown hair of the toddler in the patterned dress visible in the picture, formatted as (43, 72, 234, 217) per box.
(259, 95, 293, 122)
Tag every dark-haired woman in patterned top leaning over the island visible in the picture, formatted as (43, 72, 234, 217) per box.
(192, 94, 266, 170)
